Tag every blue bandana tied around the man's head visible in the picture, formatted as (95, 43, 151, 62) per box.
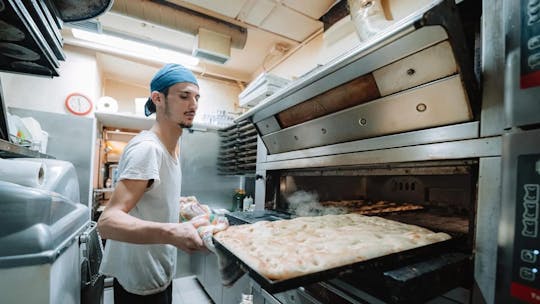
(144, 63, 199, 116)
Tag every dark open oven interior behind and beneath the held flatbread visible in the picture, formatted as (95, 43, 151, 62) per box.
(265, 159, 478, 303)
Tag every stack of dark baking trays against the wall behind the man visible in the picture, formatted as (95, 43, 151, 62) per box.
(218, 121, 257, 175)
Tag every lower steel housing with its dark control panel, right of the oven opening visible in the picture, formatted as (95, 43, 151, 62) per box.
(497, 129, 540, 303)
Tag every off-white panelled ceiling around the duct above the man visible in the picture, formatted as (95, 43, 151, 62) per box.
(68, 0, 342, 85)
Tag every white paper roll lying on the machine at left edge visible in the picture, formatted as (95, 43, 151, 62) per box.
(0, 159, 45, 188)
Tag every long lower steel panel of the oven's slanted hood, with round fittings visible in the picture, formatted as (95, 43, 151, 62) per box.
(262, 75, 472, 154)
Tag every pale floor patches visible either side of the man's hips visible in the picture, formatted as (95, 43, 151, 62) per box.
(103, 276, 214, 304)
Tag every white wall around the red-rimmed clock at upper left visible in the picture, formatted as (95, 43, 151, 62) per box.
(0, 45, 101, 116)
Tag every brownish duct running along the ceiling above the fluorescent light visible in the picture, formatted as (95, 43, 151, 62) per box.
(111, 0, 247, 49)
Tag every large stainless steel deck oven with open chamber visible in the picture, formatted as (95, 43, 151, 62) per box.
(231, 0, 505, 303)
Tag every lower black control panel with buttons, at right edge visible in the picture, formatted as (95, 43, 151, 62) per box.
(510, 154, 540, 303)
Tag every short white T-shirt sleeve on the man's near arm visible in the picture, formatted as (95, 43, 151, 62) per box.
(118, 141, 162, 187)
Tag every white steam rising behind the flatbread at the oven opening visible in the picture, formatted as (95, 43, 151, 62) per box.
(285, 190, 347, 216)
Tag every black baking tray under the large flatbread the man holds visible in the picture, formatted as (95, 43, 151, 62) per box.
(213, 235, 466, 293)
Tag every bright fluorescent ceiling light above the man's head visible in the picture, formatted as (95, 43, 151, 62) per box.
(71, 28, 199, 67)
